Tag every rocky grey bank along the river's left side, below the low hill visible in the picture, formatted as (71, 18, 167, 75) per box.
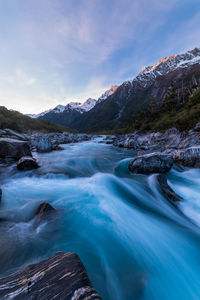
(0, 129, 92, 170)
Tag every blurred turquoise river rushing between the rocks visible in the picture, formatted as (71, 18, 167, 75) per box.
(0, 140, 200, 300)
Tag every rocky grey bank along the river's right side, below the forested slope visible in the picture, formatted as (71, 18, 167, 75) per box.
(107, 123, 200, 167)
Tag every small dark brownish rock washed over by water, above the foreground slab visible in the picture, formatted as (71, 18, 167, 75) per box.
(34, 202, 56, 226)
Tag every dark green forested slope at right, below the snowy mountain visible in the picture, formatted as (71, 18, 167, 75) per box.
(125, 86, 200, 132)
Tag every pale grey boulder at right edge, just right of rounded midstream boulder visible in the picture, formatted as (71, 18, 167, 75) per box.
(172, 146, 200, 168)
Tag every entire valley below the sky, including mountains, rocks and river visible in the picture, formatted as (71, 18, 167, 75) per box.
(0, 48, 200, 300)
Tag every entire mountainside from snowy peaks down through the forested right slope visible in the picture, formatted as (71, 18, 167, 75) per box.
(30, 48, 200, 133)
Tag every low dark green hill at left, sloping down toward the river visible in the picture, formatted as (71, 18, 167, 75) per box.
(0, 106, 74, 132)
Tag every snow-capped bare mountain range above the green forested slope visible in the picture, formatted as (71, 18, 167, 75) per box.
(27, 48, 200, 132)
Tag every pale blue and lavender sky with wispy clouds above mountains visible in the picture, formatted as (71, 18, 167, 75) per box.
(0, 0, 200, 113)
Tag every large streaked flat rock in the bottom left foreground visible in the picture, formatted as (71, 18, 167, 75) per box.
(0, 252, 101, 300)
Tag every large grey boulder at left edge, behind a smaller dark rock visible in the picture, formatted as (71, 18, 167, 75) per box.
(0, 138, 32, 159)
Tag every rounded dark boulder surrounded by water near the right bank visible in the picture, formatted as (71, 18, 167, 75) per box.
(128, 153, 173, 175)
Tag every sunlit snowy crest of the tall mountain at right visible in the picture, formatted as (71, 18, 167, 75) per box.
(133, 48, 200, 87)
